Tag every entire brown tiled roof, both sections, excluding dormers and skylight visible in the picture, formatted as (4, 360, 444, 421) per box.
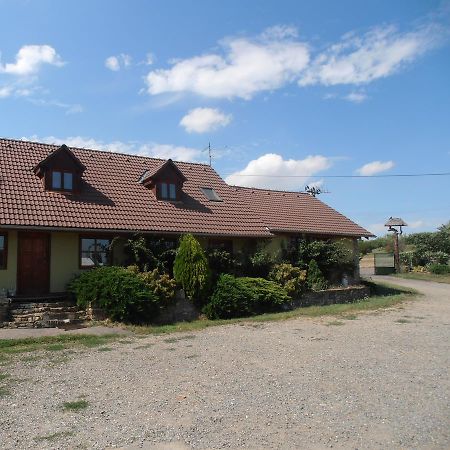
(0, 139, 371, 237)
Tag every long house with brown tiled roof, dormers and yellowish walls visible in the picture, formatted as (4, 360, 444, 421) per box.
(0, 139, 372, 296)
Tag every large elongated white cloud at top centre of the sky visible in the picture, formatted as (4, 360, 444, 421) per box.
(146, 26, 309, 99)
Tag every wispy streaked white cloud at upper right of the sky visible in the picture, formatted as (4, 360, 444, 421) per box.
(299, 25, 443, 86)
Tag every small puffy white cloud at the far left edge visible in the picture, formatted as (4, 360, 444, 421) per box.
(0, 45, 64, 76)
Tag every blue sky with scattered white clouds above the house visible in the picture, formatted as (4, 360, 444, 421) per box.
(0, 0, 450, 234)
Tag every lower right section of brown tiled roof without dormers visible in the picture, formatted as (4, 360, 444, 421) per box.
(237, 187, 373, 237)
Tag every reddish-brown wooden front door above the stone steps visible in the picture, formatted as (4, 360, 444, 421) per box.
(17, 232, 50, 295)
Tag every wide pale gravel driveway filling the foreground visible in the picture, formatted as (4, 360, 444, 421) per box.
(0, 278, 450, 449)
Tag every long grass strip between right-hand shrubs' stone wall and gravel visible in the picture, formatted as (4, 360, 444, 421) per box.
(127, 282, 419, 336)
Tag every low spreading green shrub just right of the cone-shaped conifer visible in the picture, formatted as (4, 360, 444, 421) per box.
(203, 274, 290, 319)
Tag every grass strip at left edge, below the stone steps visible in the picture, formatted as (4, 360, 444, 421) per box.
(0, 334, 119, 360)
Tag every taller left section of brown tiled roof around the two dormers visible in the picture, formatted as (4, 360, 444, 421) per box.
(0, 139, 270, 237)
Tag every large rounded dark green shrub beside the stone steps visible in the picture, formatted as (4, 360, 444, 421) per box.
(68, 267, 159, 323)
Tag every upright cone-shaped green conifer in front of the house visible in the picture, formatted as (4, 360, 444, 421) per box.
(173, 234, 210, 301)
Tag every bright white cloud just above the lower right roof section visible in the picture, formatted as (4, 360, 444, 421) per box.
(225, 153, 332, 190)
